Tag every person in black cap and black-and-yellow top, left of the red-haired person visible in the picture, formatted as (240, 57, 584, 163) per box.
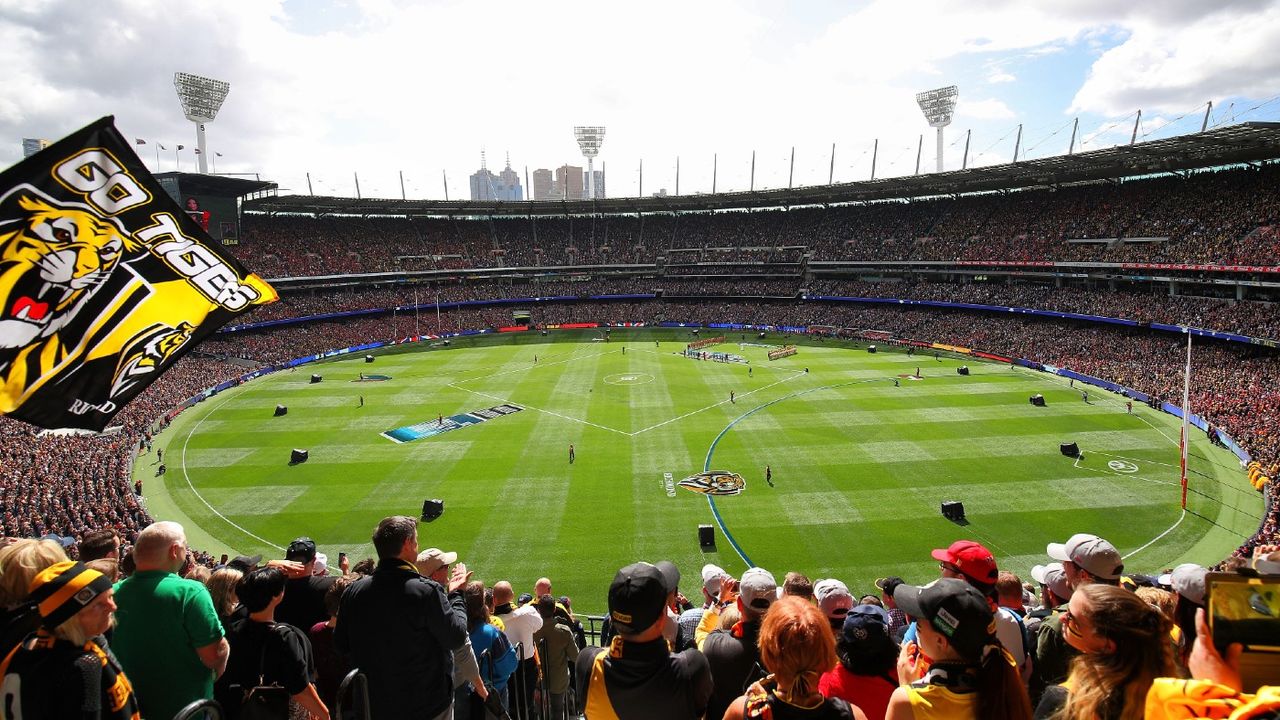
(577, 562, 712, 720)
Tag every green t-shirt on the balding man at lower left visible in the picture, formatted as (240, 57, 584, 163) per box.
(111, 570, 223, 720)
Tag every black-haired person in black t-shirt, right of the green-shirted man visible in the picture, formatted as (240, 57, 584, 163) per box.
(214, 568, 329, 720)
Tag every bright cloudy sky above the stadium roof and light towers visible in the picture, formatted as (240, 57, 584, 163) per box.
(0, 0, 1280, 199)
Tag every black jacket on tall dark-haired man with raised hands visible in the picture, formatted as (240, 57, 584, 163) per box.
(334, 557, 467, 720)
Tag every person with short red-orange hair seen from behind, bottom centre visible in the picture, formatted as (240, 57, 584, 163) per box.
(724, 596, 867, 720)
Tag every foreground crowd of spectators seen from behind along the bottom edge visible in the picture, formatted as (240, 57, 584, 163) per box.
(0, 516, 1280, 720)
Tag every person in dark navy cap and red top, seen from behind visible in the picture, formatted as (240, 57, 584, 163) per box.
(818, 605, 897, 720)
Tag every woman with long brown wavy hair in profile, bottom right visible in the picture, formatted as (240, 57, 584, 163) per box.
(1036, 584, 1178, 720)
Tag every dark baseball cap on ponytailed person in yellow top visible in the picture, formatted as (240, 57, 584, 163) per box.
(893, 578, 996, 659)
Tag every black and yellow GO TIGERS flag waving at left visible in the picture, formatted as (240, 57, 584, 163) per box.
(0, 117, 276, 430)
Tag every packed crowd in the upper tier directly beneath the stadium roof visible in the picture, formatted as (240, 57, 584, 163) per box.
(233, 165, 1280, 278)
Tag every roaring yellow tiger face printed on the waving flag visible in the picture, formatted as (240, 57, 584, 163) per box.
(0, 195, 140, 348)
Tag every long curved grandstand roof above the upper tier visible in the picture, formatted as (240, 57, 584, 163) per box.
(244, 123, 1280, 217)
